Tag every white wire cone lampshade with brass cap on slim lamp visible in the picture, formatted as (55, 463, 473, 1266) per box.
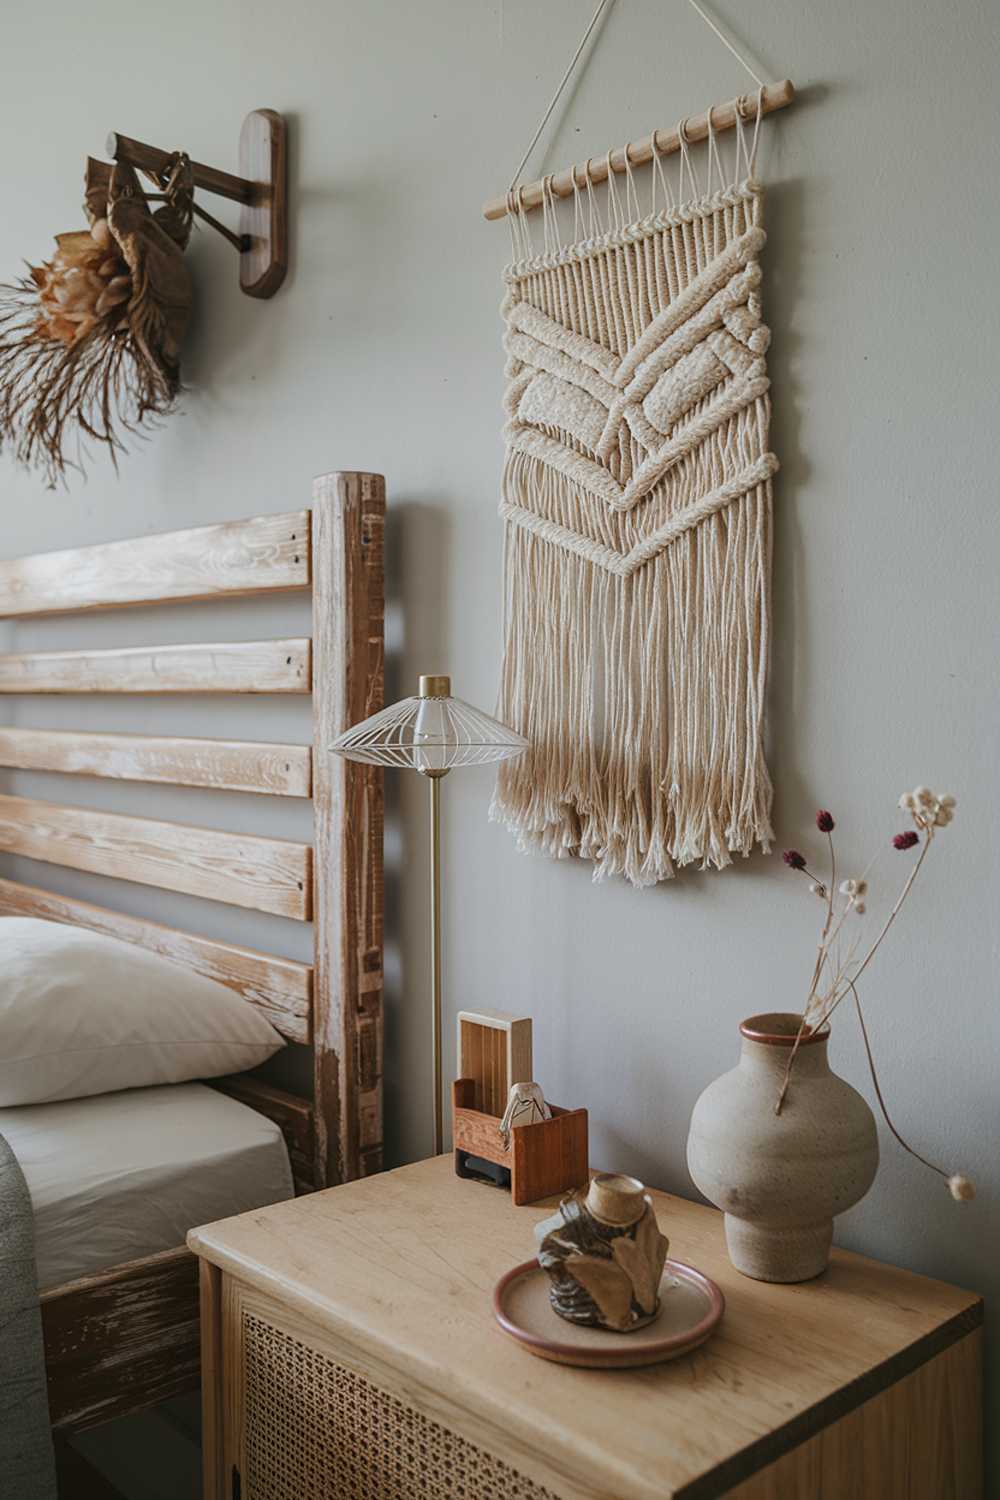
(330, 677, 528, 776)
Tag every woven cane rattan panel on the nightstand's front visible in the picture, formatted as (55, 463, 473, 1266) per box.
(241, 1311, 556, 1500)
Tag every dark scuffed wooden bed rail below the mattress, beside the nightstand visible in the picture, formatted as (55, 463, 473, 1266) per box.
(40, 1247, 201, 1431)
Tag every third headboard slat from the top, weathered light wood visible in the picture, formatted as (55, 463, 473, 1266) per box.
(0, 726, 312, 797)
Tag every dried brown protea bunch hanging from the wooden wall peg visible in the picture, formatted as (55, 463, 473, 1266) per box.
(0, 153, 193, 485)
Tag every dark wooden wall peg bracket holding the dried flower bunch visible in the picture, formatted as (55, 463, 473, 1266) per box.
(106, 110, 288, 297)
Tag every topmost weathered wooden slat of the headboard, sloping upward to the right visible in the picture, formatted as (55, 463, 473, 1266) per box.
(0, 510, 309, 617)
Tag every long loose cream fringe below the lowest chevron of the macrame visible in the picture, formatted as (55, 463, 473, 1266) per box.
(490, 453, 772, 887)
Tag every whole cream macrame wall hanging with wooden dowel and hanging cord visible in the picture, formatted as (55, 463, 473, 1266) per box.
(484, 0, 793, 887)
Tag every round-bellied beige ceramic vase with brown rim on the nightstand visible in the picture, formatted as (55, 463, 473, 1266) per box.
(688, 1013, 879, 1281)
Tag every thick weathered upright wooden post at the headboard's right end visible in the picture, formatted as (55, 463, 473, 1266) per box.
(310, 473, 385, 1188)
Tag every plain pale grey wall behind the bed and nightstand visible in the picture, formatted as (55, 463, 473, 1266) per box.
(0, 0, 1000, 1464)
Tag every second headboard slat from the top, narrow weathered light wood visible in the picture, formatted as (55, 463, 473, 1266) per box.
(0, 638, 310, 693)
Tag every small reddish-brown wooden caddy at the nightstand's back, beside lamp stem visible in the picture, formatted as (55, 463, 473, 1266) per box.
(451, 1011, 589, 1208)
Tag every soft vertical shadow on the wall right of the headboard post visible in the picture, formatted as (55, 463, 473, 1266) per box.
(384, 494, 453, 1167)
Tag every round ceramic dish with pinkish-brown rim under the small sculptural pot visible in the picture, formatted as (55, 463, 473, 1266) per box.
(493, 1260, 726, 1370)
